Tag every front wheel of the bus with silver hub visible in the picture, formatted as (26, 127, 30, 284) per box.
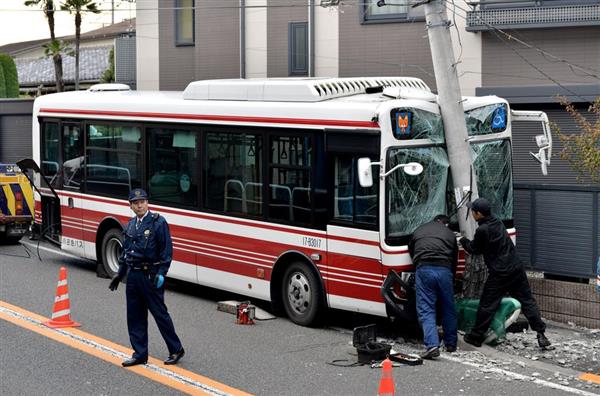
(281, 261, 324, 326)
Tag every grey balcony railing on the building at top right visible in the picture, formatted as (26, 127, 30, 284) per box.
(467, 1, 600, 32)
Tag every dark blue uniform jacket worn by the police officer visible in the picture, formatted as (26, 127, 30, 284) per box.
(119, 211, 173, 276)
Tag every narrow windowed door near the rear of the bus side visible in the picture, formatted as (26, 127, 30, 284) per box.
(60, 122, 85, 256)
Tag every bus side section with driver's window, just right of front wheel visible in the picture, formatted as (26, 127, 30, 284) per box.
(326, 131, 382, 314)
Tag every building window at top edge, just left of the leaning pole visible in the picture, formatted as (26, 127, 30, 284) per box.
(359, 0, 425, 23)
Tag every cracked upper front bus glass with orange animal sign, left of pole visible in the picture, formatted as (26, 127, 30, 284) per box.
(391, 108, 444, 143)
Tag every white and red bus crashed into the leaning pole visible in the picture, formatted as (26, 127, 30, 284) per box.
(25, 77, 549, 325)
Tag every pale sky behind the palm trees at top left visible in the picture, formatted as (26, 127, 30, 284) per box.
(0, 0, 135, 45)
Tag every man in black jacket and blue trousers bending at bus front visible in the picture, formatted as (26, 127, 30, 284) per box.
(408, 215, 458, 359)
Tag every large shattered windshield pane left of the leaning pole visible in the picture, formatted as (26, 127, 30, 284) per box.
(386, 147, 448, 244)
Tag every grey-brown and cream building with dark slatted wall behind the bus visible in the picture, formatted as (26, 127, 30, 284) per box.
(137, 0, 600, 278)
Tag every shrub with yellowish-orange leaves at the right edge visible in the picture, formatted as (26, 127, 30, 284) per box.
(553, 97, 600, 183)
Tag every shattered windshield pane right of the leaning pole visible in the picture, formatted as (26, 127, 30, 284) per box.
(471, 139, 513, 220)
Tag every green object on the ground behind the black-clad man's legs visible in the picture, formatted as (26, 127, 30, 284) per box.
(456, 297, 521, 345)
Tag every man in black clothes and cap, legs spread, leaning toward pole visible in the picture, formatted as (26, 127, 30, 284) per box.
(460, 198, 550, 348)
